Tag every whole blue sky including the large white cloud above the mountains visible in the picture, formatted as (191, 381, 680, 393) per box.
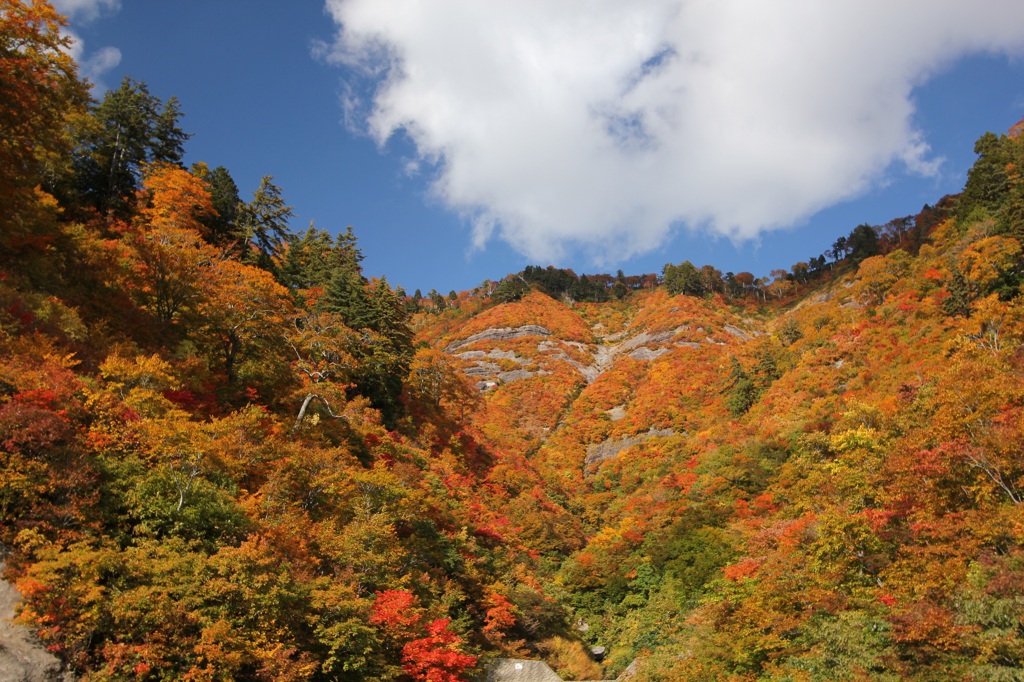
(63, 0, 1024, 293)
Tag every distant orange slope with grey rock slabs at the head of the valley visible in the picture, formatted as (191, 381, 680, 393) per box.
(419, 291, 763, 491)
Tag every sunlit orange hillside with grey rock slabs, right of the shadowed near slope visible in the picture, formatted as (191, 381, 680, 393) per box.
(411, 168, 1024, 680)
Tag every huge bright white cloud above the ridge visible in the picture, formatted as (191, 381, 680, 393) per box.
(324, 0, 1024, 262)
